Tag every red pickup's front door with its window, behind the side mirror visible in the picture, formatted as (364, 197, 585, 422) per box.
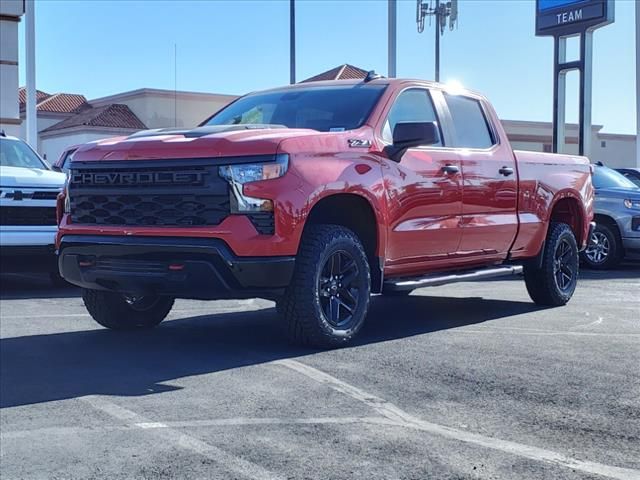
(382, 87, 462, 274)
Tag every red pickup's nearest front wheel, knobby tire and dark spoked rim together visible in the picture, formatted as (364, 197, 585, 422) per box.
(278, 225, 371, 348)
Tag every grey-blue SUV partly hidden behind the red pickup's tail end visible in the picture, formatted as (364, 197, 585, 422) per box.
(582, 165, 640, 269)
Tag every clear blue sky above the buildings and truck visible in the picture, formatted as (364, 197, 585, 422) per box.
(20, 0, 636, 134)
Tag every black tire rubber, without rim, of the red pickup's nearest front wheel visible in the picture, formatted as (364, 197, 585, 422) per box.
(277, 225, 371, 348)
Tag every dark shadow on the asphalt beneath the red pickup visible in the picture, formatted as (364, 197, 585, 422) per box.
(0, 296, 537, 408)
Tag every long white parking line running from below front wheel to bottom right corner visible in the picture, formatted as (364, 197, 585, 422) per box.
(273, 359, 640, 480)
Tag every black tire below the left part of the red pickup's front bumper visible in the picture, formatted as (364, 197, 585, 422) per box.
(82, 288, 174, 330)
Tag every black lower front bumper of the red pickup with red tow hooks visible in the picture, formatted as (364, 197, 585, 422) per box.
(58, 235, 295, 300)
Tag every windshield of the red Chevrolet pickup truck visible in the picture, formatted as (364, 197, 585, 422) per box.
(205, 84, 385, 132)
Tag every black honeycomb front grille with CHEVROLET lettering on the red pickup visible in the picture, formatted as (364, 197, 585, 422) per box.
(69, 161, 230, 227)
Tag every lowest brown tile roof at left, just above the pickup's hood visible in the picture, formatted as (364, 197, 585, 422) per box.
(42, 103, 147, 133)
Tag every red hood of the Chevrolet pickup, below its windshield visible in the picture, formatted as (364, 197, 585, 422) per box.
(74, 125, 342, 161)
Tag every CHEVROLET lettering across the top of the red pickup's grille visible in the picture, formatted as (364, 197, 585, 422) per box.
(71, 172, 206, 186)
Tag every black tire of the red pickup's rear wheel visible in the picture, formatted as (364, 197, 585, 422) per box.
(524, 223, 580, 307)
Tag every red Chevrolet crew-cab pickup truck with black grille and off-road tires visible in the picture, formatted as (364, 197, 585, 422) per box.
(57, 75, 593, 347)
